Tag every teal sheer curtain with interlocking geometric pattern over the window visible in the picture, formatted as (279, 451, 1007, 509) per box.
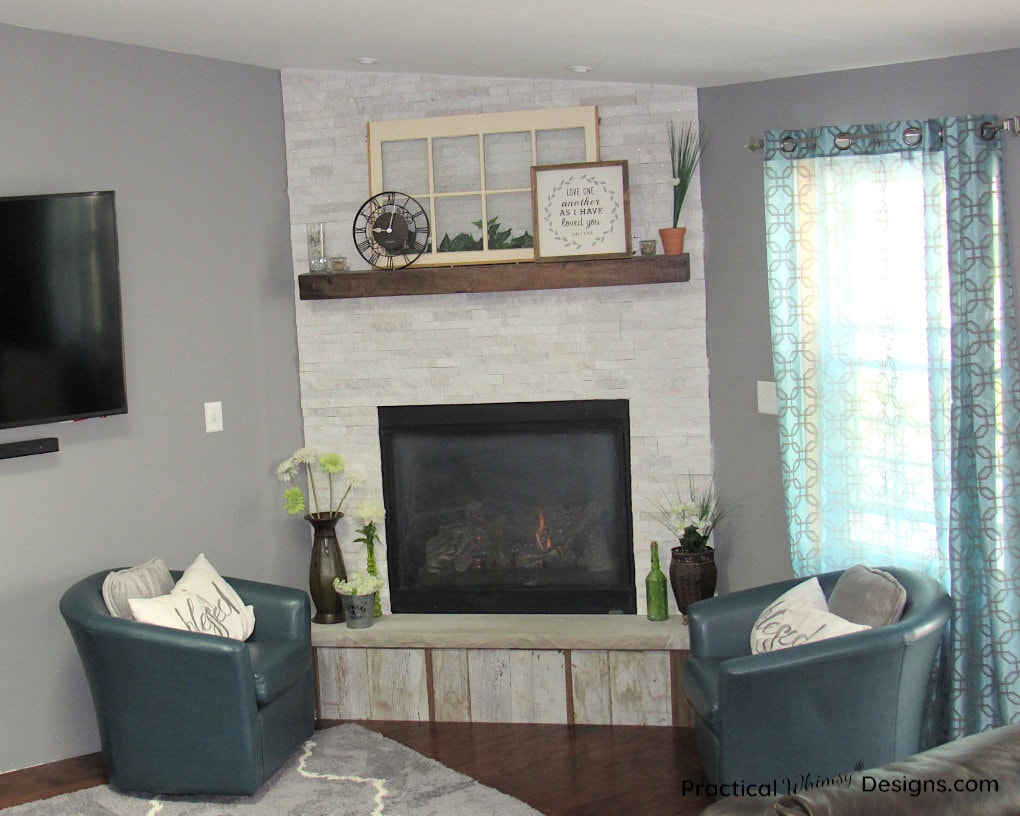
(765, 117, 1020, 737)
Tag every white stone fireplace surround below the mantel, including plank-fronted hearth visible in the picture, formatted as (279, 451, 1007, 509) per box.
(299, 281, 710, 725)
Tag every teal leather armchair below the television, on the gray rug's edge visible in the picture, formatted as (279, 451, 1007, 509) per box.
(60, 571, 315, 795)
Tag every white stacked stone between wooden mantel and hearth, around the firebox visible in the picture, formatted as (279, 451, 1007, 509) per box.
(298, 281, 711, 612)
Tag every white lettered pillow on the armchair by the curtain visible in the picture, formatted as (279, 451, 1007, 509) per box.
(751, 578, 871, 655)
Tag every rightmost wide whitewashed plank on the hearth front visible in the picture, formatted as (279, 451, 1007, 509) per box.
(609, 651, 673, 725)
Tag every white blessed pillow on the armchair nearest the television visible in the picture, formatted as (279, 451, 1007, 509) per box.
(128, 554, 255, 641)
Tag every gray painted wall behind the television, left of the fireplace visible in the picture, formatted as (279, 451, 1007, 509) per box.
(0, 27, 308, 772)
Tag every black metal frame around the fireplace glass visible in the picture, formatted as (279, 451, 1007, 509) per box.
(377, 400, 638, 614)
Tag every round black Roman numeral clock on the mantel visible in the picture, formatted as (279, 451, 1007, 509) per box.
(354, 193, 428, 269)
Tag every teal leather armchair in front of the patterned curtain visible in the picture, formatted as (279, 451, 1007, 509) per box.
(680, 567, 951, 795)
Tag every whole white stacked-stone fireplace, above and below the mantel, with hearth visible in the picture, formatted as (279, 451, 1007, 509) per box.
(284, 71, 712, 725)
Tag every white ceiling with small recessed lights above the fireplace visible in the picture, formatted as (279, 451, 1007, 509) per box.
(0, 0, 1020, 87)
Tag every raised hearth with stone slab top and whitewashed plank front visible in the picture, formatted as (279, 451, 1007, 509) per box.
(312, 615, 693, 726)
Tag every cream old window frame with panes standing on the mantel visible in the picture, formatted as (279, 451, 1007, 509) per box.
(368, 105, 600, 266)
